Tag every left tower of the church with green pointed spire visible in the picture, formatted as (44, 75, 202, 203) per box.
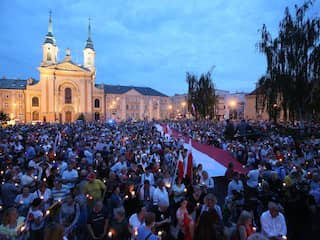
(41, 11, 58, 66)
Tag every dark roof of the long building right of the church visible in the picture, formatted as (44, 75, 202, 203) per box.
(103, 84, 167, 97)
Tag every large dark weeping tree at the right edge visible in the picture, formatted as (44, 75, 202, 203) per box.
(257, 1, 320, 123)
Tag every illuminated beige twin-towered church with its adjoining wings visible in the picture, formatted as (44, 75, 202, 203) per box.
(0, 15, 172, 122)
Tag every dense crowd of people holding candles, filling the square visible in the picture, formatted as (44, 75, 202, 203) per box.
(0, 120, 320, 240)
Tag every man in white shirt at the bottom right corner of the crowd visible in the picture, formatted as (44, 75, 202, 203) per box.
(260, 202, 287, 239)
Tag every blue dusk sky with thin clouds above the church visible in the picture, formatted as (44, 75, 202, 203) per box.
(0, 0, 320, 95)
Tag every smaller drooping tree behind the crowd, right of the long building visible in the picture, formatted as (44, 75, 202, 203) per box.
(186, 72, 216, 119)
